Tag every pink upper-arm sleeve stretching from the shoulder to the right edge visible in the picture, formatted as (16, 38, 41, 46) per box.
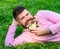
(37, 10, 60, 23)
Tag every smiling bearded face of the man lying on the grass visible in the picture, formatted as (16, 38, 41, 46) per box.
(17, 9, 33, 27)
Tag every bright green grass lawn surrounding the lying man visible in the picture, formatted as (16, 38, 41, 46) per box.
(0, 0, 60, 49)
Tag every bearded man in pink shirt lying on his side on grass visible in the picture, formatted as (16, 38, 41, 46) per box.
(5, 7, 60, 46)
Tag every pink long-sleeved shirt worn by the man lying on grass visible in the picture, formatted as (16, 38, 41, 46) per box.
(5, 10, 60, 46)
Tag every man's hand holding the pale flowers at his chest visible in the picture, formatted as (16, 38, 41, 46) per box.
(29, 26, 50, 35)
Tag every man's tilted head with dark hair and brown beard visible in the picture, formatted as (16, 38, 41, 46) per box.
(13, 6, 33, 27)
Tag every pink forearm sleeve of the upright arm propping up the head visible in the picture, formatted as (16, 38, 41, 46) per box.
(5, 25, 16, 46)
